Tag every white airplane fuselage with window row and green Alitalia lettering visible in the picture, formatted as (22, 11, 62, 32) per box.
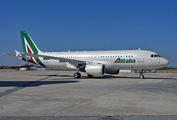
(39, 50, 169, 70)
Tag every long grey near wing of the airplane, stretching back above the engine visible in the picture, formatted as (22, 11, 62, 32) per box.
(21, 53, 92, 67)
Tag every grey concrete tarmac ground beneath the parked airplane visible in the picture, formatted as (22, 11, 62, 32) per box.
(0, 70, 177, 120)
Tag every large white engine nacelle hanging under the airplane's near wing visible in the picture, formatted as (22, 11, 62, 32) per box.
(85, 64, 105, 76)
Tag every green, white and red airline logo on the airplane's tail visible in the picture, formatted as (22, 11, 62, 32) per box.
(20, 31, 45, 66)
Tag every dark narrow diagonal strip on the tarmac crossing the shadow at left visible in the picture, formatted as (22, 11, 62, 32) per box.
(0, 73, 58, 97)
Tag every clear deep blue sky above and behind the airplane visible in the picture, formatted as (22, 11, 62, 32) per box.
(0, 0, 177, 67)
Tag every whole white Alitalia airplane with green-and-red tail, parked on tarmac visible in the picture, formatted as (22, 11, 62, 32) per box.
(3, 31, 169, 79)
